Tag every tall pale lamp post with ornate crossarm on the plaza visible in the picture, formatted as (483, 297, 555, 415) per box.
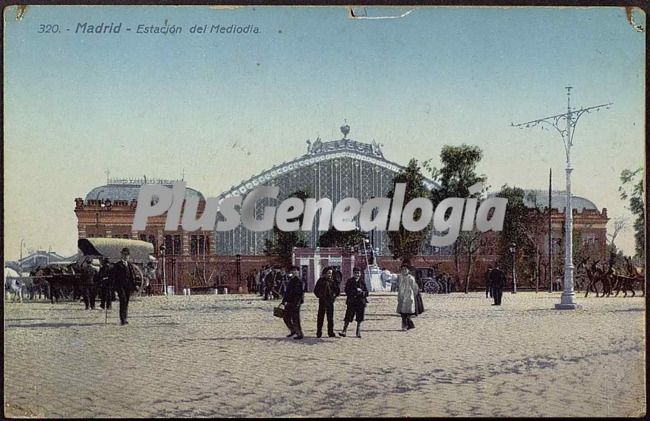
(511, 86, 612, 310)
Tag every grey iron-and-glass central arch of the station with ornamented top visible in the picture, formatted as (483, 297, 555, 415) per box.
(215, 130, 438, 256)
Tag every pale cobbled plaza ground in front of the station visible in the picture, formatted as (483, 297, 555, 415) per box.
(4, 292, 646, 418)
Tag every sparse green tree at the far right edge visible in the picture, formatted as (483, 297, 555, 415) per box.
(618, 168, 645, 260)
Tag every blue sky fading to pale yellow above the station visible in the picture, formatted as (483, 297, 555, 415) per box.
(3, 6, 645, 259)
